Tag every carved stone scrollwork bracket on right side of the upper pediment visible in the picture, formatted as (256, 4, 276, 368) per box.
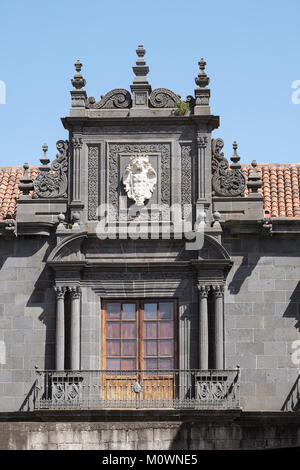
(212, 139, 246, 197)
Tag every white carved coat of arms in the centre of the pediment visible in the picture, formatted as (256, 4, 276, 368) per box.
(123, 153, 157, 206)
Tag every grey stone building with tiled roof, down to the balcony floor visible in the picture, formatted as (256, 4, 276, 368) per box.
(0, 46, 300, 448)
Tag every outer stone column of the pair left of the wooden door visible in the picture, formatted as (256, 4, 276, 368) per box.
(54, 286, 66, 370)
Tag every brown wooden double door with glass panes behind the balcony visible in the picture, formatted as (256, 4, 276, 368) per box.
(101, 299, 178, 402)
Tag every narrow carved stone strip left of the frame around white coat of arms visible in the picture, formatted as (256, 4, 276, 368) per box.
(88, 145, 99, 220)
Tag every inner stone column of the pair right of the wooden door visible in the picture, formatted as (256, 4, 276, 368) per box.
(198, 285, 210, 370)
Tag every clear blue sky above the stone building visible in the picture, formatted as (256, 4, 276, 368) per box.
(0, 0, 300, 166)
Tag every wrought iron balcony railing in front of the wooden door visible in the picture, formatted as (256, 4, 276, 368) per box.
(34, 369, 240, 409)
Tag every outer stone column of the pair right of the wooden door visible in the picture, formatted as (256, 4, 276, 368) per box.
(213, 285, 224, 370)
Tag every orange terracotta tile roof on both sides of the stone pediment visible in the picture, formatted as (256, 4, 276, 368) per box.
(0, 163, 300, 220)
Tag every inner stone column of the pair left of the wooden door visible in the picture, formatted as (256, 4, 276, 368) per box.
(69, 286, 81, 370)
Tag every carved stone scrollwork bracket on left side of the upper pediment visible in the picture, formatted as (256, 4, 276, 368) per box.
(33, 140, 69, 198)
